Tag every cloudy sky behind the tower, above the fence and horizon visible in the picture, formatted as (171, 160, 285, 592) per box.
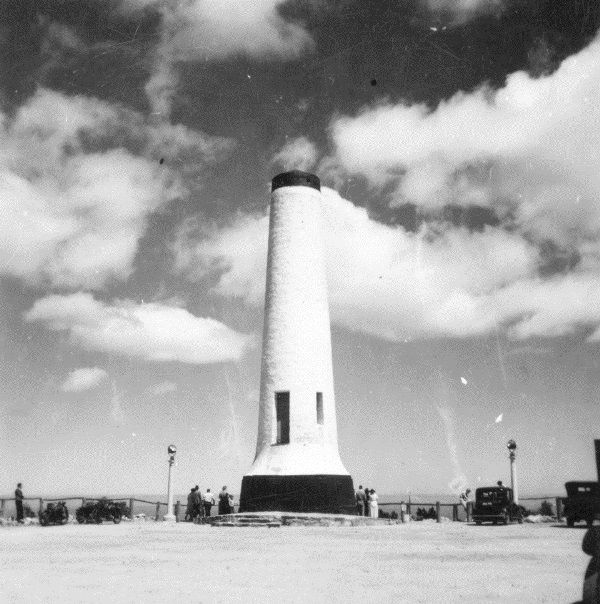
(0, 0, 600, 495)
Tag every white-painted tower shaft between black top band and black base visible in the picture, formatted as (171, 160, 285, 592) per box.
(248, 186, 348, 475)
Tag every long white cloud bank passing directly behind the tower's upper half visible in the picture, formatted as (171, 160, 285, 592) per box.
(173, 187, 580, 339)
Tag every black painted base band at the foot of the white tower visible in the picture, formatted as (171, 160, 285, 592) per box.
(240, 474, 356, 514)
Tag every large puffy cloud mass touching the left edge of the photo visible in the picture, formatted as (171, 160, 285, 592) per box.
(0, 89, 232, 289)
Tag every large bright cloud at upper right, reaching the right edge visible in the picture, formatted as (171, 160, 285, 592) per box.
(331, 31, 600, 266)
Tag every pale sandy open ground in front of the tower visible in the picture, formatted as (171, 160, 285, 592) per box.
(0, 522, 589, 604)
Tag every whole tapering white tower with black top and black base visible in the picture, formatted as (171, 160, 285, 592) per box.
(240, 171, 356, 513)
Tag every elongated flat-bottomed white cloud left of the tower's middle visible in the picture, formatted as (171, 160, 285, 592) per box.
(25, 293, 252, 364)
